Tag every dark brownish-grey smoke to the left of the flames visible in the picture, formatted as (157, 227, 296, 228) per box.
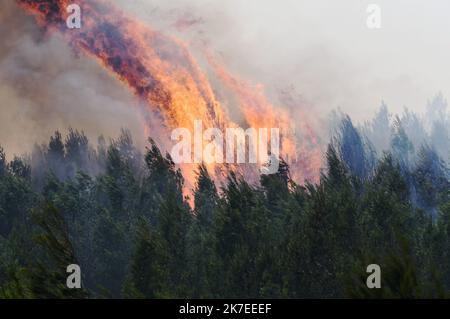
(0, 1, 144, 157)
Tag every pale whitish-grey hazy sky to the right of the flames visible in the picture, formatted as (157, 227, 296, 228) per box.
(120, 0, 450, 119)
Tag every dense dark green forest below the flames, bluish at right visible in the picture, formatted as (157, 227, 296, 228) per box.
(0, 96, 450, 298)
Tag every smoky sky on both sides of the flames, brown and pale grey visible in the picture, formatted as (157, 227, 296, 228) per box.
(0, 0, 450, 156)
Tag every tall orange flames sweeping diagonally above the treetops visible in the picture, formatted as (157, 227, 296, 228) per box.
(16, 0, 321, 189)
